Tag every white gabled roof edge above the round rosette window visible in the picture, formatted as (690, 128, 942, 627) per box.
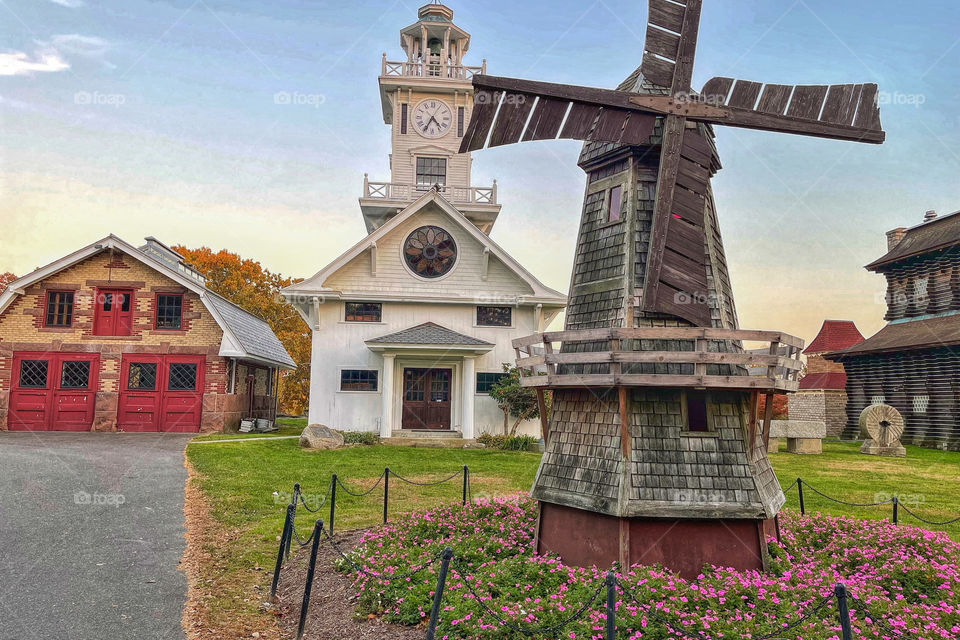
(283, 189, 567, 307)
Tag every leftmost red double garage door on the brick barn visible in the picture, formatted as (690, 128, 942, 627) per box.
(8, 353, 100, 431)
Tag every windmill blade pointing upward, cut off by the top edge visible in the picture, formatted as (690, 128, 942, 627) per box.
(640, 0, 702, 93)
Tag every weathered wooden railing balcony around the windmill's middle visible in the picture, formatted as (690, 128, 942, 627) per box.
(513, 327, 803, 393)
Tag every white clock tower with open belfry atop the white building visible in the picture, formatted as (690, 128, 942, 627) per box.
(360, 4, 500, 234)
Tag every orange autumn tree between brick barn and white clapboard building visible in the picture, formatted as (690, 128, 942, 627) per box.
(173, 246, 310, 416)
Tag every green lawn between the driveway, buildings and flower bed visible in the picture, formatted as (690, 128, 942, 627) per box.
(187, 420, 960, 629)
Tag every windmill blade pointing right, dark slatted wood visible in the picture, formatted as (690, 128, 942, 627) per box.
(688, 77, 886, 144)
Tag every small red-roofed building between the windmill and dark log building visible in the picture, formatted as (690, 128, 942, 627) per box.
(788, 320, 863, 437)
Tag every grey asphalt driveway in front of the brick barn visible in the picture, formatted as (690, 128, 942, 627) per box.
(0, 432, 189, 640)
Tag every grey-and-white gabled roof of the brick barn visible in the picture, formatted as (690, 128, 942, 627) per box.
(0, 234, 296, 369)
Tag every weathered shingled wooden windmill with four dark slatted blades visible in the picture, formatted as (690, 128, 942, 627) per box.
(460, 0, 884, 575)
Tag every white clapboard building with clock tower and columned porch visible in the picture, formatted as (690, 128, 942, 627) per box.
(284, 4, 566, 438)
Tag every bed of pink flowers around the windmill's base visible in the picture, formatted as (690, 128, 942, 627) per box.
(344, 496, 960, 640)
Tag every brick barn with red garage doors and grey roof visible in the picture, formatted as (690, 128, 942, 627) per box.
(0, 235, 294, 432)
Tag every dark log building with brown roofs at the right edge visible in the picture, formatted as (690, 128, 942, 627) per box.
(826, 211, 960, 450)
